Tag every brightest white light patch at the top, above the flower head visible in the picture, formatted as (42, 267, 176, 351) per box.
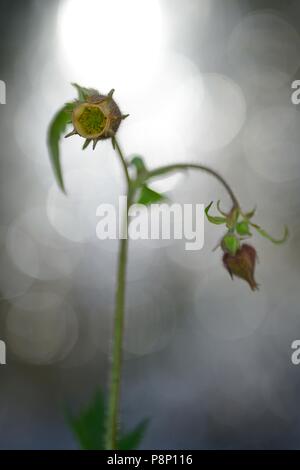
(58, 0, 162, 93)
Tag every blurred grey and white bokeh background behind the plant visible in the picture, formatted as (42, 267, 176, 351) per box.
(0, 0, 300, 449)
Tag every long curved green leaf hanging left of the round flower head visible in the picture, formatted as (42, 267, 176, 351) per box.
(47, 106, 70, 192)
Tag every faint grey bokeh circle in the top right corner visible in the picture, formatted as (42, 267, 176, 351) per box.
(228, 11, 300, 89)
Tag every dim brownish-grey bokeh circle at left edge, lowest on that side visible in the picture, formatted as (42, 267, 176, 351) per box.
(6, 292, 78, 364)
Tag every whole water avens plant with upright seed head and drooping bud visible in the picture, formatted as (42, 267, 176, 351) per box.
(48, 84, 288, 449)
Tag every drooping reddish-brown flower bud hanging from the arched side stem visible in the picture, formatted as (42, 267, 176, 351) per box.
(223, 244, 258, 291)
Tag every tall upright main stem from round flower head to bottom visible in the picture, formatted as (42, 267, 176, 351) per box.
(105, 138, 133, 450)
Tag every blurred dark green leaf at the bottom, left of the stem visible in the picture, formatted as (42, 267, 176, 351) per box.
(67, 392, 106, 450)
